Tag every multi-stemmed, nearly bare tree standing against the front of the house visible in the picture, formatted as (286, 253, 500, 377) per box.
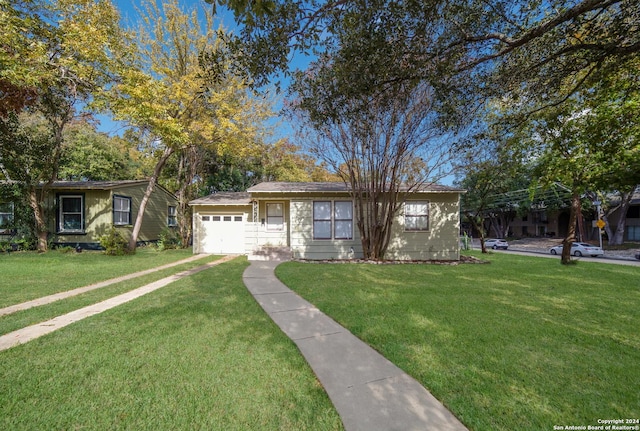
(294, 75, 458, 260)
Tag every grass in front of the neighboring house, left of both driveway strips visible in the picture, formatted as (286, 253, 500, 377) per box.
(0, 247, 192, 308)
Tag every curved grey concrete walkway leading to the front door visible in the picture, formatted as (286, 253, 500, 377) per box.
(243, 261, 467, 431)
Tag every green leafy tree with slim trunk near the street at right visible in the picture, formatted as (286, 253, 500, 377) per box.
(508, 93, 639, 263)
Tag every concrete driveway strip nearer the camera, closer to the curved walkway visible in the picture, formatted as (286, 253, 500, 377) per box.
(0, 255, 237, 351)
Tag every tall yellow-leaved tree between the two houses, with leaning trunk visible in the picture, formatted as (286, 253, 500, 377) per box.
(110, 0, 270, 250)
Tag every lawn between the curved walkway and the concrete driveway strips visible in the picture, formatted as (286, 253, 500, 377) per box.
(0, 259, 342, 430)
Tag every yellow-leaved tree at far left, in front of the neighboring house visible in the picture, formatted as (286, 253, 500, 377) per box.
(0, 0, 126, 251)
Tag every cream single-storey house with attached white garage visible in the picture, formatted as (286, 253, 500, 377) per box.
(190, 182, 463, 260)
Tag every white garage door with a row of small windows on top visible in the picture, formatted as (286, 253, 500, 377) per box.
(200, 214, 244, 254)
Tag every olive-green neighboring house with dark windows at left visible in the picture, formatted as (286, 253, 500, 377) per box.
(46, 180, 178, 249)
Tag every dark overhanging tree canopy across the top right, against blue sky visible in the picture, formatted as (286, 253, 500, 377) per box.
(207, 0, 640, 103)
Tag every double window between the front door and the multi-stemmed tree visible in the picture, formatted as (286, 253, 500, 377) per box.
(313, 201, 353, 239)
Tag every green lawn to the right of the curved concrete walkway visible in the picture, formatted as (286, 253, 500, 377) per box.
(276, 254, 640, 430)
